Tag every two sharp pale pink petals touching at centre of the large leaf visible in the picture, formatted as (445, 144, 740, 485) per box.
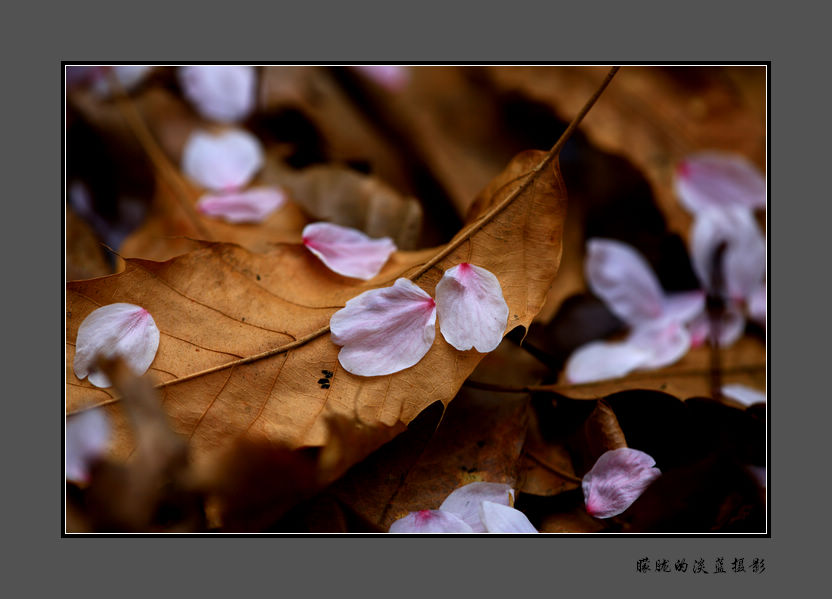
(330, 263, 508, 376)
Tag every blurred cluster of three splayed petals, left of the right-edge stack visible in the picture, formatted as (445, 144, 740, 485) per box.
(566, 239, 705, 383)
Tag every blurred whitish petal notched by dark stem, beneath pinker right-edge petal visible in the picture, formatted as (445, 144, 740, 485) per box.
(691, 207, 766, 301)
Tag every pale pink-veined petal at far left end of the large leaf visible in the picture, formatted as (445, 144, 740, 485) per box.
(72, 303, 159, 387)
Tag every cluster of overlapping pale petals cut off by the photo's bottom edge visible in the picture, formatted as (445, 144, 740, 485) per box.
(389, 483, 537, 534)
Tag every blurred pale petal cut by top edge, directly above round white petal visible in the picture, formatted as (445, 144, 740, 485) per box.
(179, 65, 257, 123)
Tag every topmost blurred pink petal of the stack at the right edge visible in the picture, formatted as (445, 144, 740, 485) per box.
(675, 152, 766, 214)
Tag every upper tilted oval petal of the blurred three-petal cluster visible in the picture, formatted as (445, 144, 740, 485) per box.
(585, 239, 664, 326)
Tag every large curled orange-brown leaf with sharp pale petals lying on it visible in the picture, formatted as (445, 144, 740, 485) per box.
(66, 151, 566, 488)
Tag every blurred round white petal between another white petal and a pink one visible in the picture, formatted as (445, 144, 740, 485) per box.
(182, 129, 263, 191)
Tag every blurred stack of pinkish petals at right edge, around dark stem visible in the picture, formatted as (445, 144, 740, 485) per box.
(675, 152, 766, 346)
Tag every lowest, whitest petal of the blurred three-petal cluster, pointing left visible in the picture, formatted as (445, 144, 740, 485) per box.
(566, 341, 650, 383)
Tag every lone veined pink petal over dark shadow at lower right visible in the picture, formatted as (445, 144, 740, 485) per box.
(582, 447, 661, 518)
